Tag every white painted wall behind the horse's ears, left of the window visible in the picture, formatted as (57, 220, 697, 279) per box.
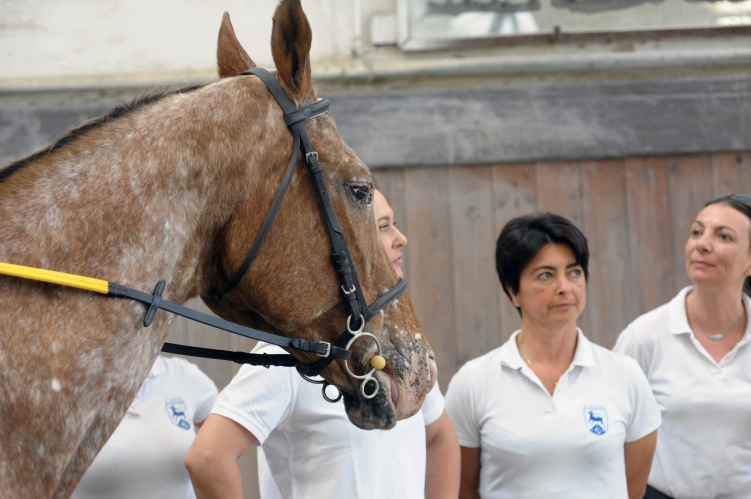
(0, 0, 395, 86)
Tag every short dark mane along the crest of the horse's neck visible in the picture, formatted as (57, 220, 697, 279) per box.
(0, 84, 205, 182)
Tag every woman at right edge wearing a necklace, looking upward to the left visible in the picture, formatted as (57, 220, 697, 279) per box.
(614, 194, 751, 499)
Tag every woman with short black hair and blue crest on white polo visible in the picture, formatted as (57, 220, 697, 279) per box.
(446, 213, 660, 499)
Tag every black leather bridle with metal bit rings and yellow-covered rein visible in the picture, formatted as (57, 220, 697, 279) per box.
(0, 68, 406, 402)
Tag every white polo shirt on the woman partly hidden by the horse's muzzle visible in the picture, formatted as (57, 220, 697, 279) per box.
(211, 342, 444, 499)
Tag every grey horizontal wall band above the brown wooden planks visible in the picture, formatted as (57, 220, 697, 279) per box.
(0, 74, 751, 168)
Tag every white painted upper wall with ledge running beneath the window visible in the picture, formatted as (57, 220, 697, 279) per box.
(0, 0, 751, 92)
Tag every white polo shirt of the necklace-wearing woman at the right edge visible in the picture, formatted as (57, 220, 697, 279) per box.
(614, 286, 751, 499)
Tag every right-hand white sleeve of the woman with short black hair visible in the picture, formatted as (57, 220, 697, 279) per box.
(625, 357, 662, 442)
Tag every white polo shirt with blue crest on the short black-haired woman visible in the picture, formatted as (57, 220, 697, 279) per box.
(446, 331, 660, 499)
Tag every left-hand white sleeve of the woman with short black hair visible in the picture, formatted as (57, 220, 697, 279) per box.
(446, 364, 480, 448)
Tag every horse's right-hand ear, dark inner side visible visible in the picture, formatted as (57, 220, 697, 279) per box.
(271, 0, 315, 103)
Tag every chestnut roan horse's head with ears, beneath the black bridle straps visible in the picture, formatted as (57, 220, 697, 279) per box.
(203, 0, 436, 428)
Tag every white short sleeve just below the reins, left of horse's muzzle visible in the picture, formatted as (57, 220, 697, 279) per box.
(211, 344, 299, 444)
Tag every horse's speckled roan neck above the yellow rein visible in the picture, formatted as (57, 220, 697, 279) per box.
(0, 81, 284, 301)
